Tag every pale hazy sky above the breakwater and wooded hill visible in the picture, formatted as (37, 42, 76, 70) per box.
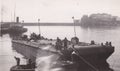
(0, 0, 120, 22)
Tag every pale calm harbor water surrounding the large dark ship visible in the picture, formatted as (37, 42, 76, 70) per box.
(0, 26, 120, 71)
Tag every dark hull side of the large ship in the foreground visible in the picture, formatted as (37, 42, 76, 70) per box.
(12, 40, 114, 71)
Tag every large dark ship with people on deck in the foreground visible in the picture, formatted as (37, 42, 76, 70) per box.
(12, 33, 114, 71)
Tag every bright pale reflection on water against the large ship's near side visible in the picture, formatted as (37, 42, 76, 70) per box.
(36, 55, 62, 71)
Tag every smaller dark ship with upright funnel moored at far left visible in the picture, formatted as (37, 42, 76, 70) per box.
(0, 17, 27, 34)
